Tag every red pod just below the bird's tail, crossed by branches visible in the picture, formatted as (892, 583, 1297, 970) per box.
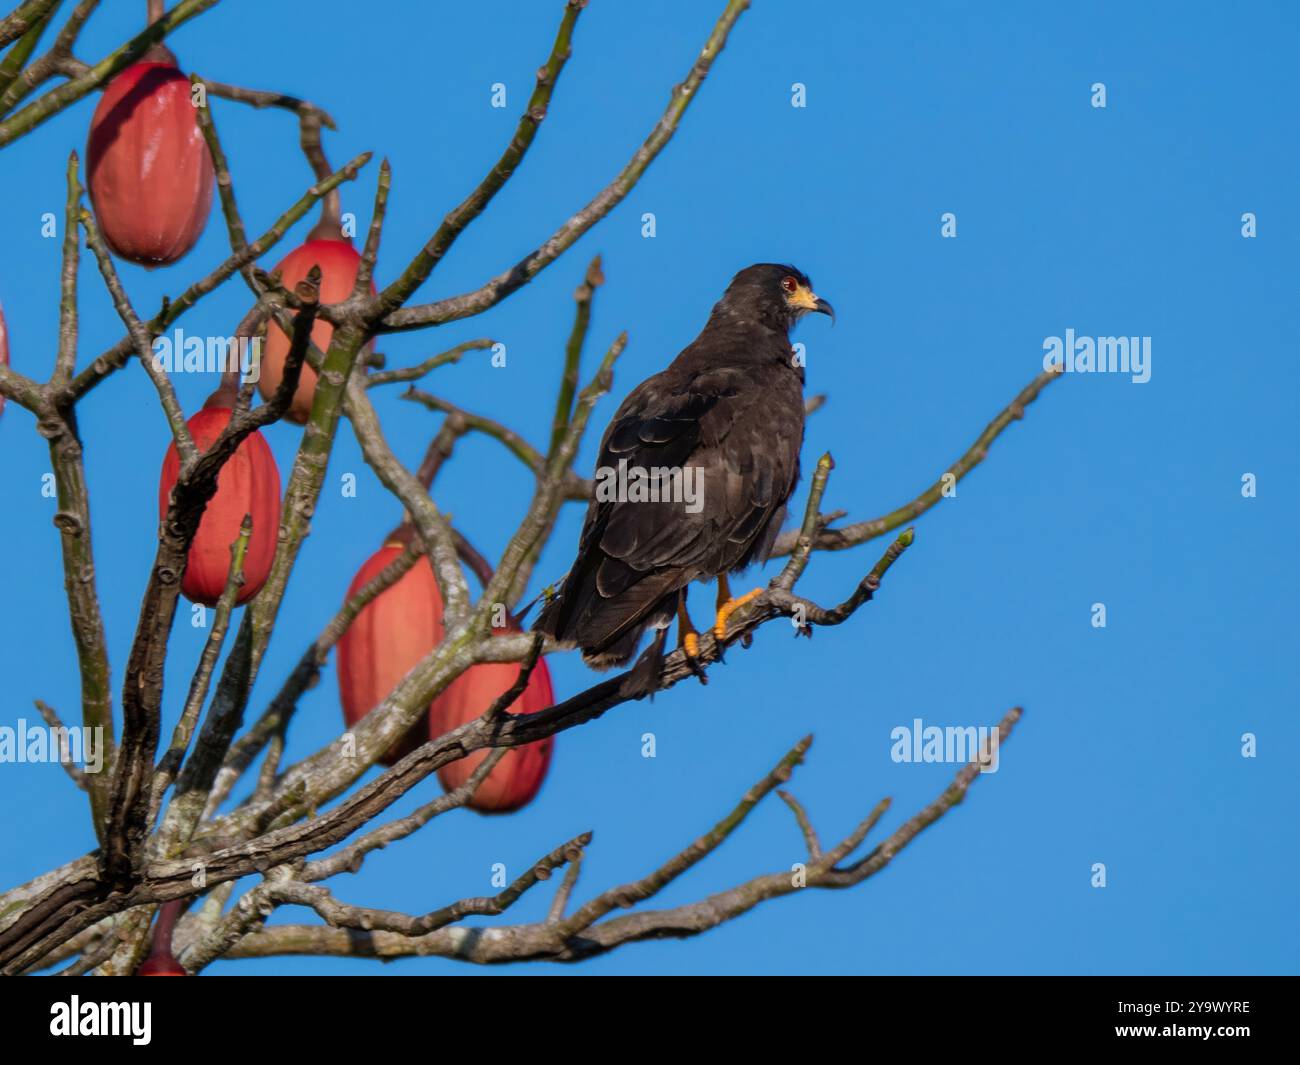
(429, 624, 555, 814)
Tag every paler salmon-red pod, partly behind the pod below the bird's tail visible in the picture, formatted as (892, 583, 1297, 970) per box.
(338, 529, 445, 766)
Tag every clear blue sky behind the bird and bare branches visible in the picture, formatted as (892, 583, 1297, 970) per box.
(0, 0, 1300, 974)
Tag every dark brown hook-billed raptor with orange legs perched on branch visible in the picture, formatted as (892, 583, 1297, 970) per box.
(533, 263, 835, 683)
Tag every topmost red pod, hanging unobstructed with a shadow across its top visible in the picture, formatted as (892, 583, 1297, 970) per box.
(86, 49, 212, 267)
